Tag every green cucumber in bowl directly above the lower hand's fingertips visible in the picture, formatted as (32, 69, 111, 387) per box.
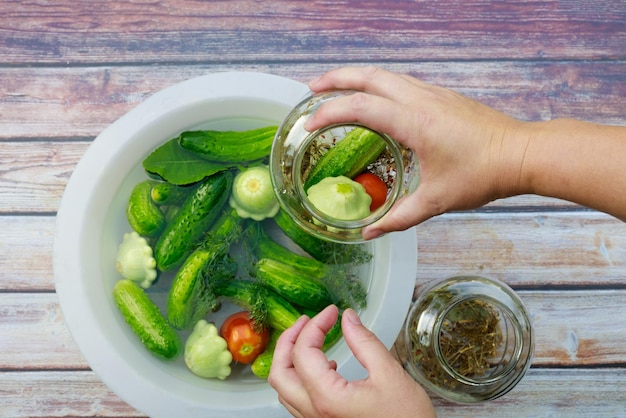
(255, 258, 333, 311)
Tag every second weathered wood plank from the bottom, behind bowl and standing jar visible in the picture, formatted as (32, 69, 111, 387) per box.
(0, 290, 626, 371)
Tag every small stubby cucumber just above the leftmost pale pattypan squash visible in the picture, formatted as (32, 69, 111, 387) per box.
(126, 180, 166, 238)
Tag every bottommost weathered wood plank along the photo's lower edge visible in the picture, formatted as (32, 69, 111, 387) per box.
(0, 368, 626, 418)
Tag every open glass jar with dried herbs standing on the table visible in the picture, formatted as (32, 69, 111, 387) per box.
(395, 276, 534, 403)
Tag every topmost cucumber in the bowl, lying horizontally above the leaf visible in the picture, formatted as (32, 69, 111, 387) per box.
(178, 126, 278, 163)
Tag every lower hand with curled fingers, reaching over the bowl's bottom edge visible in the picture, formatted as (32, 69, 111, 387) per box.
(268, 306, 435, 418)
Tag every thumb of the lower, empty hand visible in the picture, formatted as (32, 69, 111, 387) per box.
(341, 309, 395, 375)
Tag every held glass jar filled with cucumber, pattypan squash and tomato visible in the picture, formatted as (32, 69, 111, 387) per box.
(270, 91, 419, 243)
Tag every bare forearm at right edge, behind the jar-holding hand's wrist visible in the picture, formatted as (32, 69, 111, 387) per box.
(521, 119, 626, 221)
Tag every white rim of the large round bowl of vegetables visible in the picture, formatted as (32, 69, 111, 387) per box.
(53, 71, 417, 417)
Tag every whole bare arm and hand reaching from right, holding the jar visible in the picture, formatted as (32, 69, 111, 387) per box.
(305, 67, 626, 238)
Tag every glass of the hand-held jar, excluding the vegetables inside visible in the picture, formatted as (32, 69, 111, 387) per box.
(270, 91, 419, 243)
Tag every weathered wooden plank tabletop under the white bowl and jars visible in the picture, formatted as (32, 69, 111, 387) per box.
(0, 0, 626, 417)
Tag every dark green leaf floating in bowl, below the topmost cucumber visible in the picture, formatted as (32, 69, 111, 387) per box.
(143, 138, 233, 185)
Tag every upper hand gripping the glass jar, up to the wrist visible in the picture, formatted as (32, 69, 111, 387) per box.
(305, 67, 528, 239)
